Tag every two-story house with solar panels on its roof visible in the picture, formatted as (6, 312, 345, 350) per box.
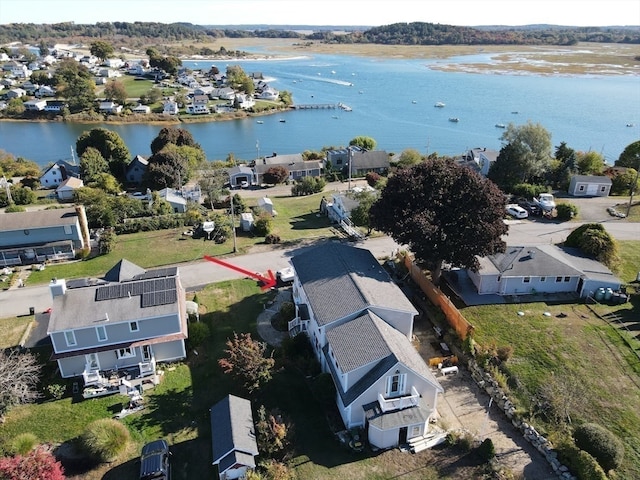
(47, 259, 187, 387)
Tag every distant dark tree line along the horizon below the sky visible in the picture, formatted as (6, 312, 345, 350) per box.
(0, 22, 640, 46)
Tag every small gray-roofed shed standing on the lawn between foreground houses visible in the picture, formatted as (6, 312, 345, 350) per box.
(210, 395, 258, 472)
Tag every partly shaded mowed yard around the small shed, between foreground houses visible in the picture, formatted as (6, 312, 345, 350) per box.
(0, 280, 484, 480)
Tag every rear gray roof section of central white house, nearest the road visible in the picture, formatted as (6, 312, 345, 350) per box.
(291, 242, 418, 326)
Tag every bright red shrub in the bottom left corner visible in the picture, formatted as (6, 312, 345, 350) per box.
(0, 447, 65, 480)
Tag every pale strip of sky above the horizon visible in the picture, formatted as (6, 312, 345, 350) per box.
(0, 0, 640, 26)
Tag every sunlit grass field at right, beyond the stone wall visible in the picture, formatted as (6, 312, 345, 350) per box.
(462, 297, 640, 478)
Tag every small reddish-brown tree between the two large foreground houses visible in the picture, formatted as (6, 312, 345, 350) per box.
(218, 332, 275, 393)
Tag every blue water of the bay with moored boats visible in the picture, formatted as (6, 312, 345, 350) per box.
(0, 55, 640, 165)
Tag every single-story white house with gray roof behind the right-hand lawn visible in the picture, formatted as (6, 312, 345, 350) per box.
(467, 245, 622, 298)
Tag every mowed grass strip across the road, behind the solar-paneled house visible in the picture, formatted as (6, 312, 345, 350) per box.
(28, 189, 336, 285)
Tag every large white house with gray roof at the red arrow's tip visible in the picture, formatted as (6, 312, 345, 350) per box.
(289, 243, 443, 448)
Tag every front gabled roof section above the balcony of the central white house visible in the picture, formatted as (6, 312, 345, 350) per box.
(324, 312, 444, 405)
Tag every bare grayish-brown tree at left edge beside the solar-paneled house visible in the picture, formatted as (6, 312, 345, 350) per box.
(0, 350, 40, 418)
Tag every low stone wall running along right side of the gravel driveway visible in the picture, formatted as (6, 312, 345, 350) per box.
(468, 359, 576, 480)
